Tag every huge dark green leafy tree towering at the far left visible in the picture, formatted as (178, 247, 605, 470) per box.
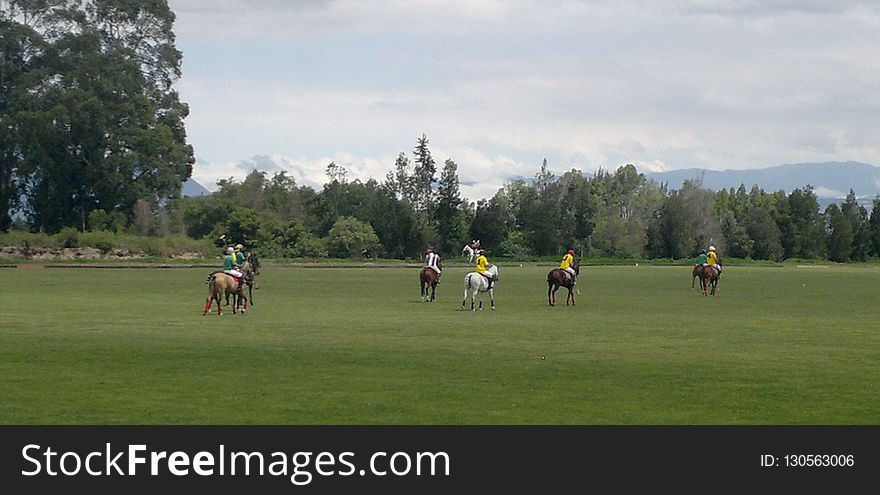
(0, 0, 193, 231)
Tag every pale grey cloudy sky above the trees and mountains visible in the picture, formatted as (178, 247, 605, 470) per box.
(169, 0, 880, 200)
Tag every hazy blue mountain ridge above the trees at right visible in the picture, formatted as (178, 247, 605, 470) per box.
(645, 162, 880, 204)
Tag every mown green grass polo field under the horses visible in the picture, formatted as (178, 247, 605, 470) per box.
(0, 264, 880, 424)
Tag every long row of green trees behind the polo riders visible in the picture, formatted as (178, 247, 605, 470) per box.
(173, 139, 880, 262)
